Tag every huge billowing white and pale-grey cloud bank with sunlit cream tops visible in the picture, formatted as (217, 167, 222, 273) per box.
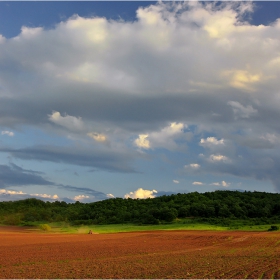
(1, 1, 279, 101)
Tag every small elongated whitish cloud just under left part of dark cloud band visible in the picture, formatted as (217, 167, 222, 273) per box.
(48, 111, 84, 131)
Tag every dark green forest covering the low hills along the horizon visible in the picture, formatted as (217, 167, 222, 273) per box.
(0, 191, 280, 228)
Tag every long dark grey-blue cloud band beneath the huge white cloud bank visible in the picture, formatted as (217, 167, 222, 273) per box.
(0, 79, 280, 133)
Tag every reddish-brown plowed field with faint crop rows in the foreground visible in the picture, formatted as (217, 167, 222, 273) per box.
(0, 228, 280, 279)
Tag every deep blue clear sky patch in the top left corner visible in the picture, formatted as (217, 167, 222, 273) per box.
(0, 1, 156, 38)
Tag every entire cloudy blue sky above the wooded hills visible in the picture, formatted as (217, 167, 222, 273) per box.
(0, 1, 280, 202)
